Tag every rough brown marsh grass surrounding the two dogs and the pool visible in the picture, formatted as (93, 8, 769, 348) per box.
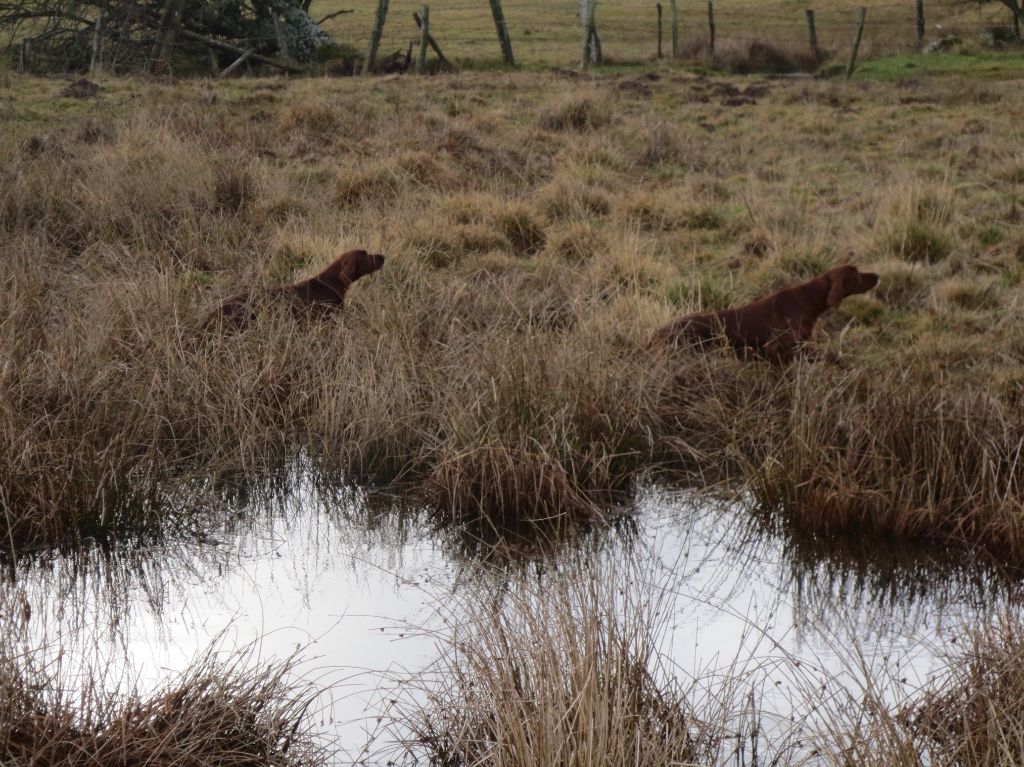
(0, 58, 1024, 765)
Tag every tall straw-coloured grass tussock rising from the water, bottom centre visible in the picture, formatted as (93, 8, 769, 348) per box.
(402, 564, 719, 767)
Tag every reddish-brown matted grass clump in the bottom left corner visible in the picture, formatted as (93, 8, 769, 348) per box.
(0, 647, 327, 767)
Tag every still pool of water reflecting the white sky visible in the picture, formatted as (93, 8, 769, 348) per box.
(8, 475, 1022, 764)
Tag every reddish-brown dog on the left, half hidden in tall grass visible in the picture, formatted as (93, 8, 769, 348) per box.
(203, 250, 384, 328)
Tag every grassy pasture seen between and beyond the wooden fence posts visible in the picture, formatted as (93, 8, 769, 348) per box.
(6, 0, 1012, 72)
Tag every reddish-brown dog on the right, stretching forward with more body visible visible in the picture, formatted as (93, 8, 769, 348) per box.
(651, 265, 879, 361)
